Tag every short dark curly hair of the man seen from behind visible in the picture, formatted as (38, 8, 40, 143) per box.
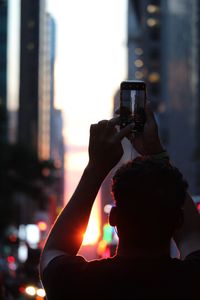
(112, 156, 188, 243)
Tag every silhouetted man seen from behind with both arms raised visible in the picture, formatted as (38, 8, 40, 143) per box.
(40, 106, 200, 300)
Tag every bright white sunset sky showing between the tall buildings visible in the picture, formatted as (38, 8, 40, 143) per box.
(8, 0, 127, 246)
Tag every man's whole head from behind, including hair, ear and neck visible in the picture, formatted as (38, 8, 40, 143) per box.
(110, 157, 188, 246)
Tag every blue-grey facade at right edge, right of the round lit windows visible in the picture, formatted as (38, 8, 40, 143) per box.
(160, 0, 200, 195)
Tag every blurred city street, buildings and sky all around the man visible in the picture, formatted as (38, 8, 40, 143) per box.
(0, 0, 200, 300)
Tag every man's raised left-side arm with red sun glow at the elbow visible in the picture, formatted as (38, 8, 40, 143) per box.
(40, 119, 132, 274)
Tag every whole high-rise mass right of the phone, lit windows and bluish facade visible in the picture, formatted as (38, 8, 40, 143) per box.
(127, 0, 200, 194)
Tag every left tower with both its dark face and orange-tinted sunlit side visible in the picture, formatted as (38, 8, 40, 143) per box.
(18, 0, 52, 160)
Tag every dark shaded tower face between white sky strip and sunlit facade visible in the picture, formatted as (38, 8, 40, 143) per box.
(18, 0, 41, 154)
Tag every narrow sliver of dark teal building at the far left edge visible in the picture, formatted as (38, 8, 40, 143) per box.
(0, 0, 8, 143)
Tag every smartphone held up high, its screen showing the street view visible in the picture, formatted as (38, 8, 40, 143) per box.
(120, 80, 146, 133)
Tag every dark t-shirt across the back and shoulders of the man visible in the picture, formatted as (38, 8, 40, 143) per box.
(43, 251, 200, 300)
